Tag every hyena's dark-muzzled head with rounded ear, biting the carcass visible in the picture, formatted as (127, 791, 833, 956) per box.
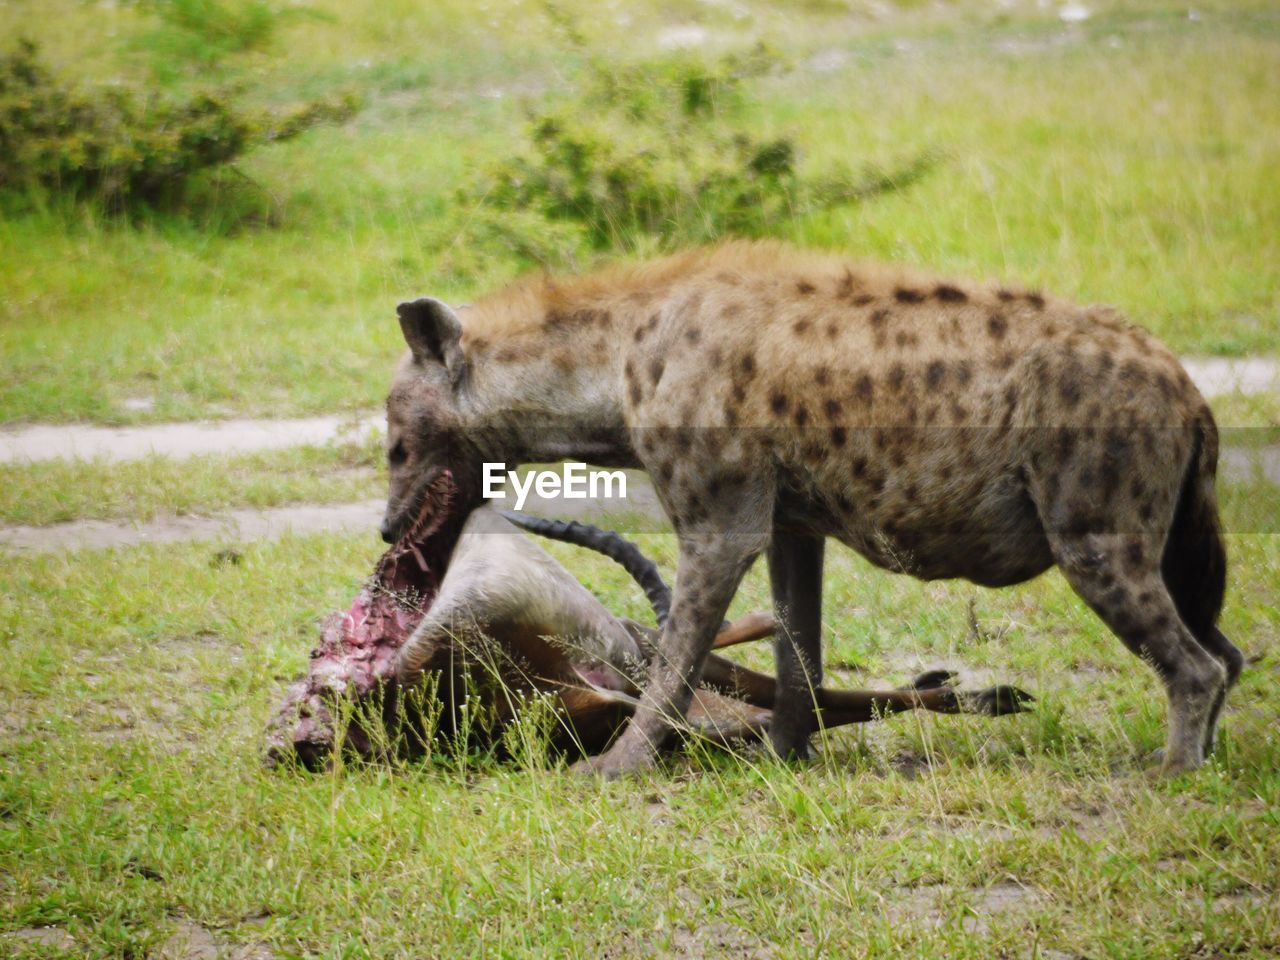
(381, 297, 481, 543)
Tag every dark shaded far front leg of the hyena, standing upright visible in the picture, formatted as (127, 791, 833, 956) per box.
(769, 527, 826, 760)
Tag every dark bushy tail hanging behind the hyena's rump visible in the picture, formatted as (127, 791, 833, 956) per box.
(1160, 410, 1226, 652)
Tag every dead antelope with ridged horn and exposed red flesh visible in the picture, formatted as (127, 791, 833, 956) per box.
(268, 488, 1030, 768)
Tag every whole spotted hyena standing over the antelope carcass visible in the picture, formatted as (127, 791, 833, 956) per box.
(383, 243, 1242, 774)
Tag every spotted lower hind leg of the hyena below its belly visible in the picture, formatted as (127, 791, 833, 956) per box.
(1051, 534, 1228, 776)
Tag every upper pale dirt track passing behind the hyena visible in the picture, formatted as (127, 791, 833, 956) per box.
(0, 357, 1280, 463)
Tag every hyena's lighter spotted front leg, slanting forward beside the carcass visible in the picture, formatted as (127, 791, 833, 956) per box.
(575, 524, 768, 778)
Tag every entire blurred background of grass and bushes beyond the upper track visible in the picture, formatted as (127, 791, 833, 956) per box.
(0, 0, 1280, 422)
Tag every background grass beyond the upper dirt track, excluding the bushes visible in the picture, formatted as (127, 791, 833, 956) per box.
(0, 0, 1280, 422)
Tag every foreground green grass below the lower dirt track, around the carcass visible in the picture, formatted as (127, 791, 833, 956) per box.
(0, 536, 1280, 957)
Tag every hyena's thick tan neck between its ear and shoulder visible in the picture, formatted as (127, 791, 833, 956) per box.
(462, 302, 636, 466)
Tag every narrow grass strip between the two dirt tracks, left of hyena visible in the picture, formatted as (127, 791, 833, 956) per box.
(0, 444, 387, 526)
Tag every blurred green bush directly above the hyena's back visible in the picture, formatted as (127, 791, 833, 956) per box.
(461, 49, 932, 259)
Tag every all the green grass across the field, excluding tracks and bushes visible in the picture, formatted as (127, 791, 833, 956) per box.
(0, 0, 1280, 960)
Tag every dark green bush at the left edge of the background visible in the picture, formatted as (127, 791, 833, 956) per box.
(0, 41, 356, 210)
